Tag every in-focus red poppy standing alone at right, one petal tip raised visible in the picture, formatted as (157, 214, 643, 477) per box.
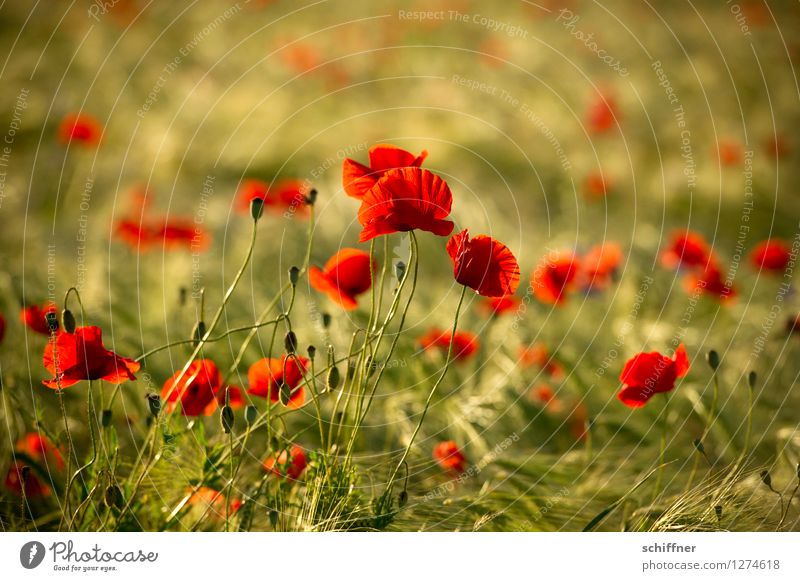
(617, 343, 689, 408)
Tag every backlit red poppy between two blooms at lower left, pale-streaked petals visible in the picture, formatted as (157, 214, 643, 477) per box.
(161, 359, 224, 417)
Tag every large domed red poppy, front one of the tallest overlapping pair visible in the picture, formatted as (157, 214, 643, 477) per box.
(358, 167, 453, 242)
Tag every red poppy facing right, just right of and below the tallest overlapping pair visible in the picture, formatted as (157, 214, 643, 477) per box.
(447, 230, 519, 297)
